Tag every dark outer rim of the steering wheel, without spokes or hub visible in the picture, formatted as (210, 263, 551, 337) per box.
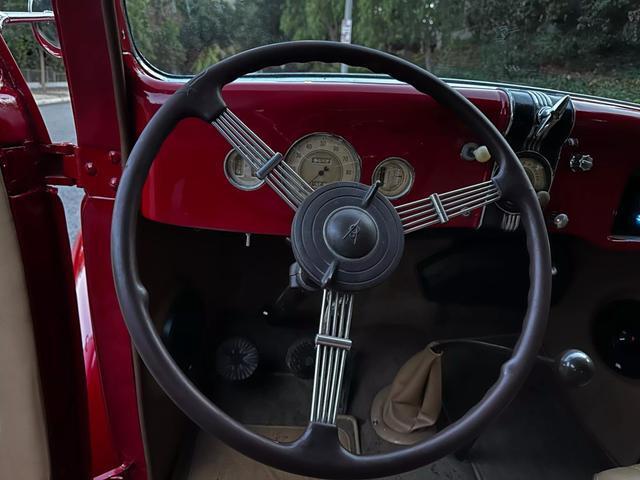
(111, 41, 551, 478)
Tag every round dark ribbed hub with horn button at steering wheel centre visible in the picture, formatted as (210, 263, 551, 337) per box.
(291, 182, 404, 291)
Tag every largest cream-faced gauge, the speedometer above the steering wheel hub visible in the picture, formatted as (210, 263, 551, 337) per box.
(284, 133, 360, 189)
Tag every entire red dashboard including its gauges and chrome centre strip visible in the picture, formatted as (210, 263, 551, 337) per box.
(137, 79, 640, 249)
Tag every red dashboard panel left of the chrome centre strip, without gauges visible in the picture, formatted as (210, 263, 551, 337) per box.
(138, 75, 509, 235)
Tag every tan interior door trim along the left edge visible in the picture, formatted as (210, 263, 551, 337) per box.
(0, 174, 51, 480)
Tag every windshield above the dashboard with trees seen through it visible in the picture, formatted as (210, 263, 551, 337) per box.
(127, 0, 640, 102)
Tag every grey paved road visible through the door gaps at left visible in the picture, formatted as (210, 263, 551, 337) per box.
(40, 102, 83, 243)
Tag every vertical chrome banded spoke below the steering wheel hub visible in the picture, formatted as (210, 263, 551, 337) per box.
(310, 290, 353, 425)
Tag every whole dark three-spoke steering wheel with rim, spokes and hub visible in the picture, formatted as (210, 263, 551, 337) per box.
(111, 41, 551, 478)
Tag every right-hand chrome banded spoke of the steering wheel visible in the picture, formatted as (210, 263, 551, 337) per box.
(396, 179, 501, 234)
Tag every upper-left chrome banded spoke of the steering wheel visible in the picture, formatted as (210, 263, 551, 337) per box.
(212, 108, 313, 210)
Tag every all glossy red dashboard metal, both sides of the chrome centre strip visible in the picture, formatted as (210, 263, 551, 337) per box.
(131, 62, 640, 249)
